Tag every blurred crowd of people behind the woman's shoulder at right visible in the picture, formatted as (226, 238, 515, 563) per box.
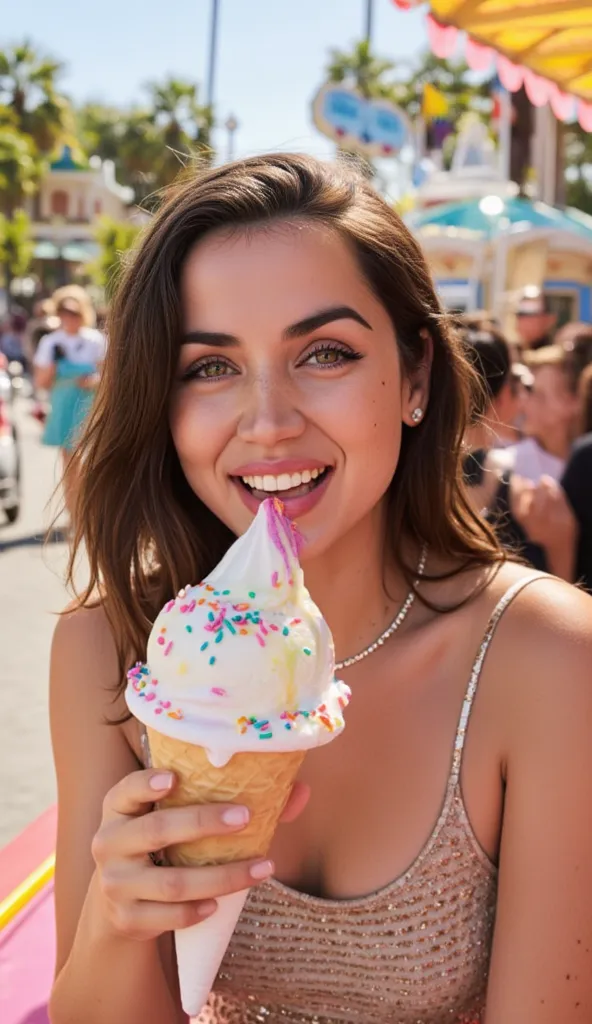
(459, 289, 592, 589)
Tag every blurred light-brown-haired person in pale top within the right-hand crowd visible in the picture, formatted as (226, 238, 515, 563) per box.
(508, 345, 580, 483)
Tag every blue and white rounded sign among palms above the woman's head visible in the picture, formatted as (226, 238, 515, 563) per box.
(312, 82, 410, 157)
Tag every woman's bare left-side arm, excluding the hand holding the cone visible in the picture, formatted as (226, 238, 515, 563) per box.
(50, 609, 185, 1024)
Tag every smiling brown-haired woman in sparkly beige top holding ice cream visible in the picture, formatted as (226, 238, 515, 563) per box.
(50, 155, 592, 1024)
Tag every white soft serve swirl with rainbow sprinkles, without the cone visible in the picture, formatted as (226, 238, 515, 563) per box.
(126, 499, 349, 766)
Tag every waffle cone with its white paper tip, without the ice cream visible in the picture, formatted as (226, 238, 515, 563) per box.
(147, 728, 305, 1016)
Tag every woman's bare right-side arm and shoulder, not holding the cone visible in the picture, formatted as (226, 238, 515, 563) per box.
(485, 582, 592, 1024)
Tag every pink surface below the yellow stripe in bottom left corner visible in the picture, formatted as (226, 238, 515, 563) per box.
(0, 884, 55, 1024)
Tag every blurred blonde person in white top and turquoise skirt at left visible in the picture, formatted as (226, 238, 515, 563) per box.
(34, 289, 104, 522)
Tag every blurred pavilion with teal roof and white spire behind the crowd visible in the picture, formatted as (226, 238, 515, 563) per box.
(407, 121, 592, 321)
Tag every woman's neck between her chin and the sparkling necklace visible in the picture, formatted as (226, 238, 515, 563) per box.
(303, 506, 409, 662)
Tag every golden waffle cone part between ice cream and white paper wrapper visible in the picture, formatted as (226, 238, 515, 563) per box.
(147, 727, 306, 866)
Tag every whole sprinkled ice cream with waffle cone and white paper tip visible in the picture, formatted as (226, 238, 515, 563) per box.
(126, 499, 349, 1016)
